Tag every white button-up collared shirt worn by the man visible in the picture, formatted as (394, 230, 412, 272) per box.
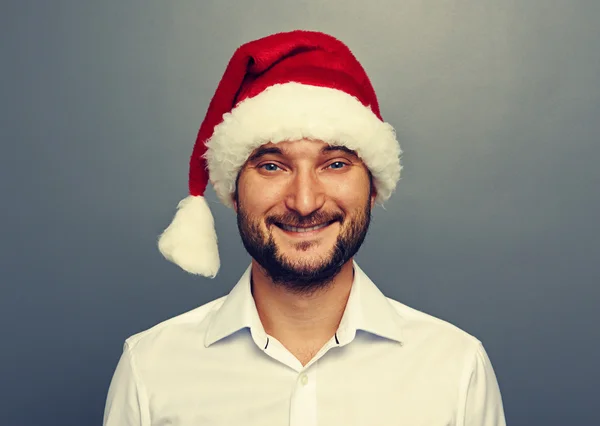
(103, 263, 506, 426)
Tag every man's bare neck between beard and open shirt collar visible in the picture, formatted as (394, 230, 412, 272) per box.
(252, 259, 354, 346)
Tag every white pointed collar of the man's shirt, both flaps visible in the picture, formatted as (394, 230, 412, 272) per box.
(204, 262, 403, 348)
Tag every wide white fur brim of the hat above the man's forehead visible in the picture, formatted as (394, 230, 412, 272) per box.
(205, 83, 402, 207)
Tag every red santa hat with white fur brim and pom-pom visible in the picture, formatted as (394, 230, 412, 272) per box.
(159, 31, 402, 277)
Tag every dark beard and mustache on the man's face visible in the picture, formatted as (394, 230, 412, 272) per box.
(237, 202, 371, 294)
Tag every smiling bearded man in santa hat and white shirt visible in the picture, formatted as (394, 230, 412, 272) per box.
(104, 31, 505, 426)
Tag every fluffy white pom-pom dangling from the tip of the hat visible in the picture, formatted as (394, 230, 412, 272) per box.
(158, 196, 220, 278)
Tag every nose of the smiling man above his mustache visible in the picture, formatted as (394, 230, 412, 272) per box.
(285, 170, 325, 216)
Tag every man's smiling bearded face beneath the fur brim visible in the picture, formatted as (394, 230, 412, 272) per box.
(234, 140, 376, 292)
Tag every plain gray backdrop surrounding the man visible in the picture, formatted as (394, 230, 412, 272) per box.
(0, 0, 600, 426)
